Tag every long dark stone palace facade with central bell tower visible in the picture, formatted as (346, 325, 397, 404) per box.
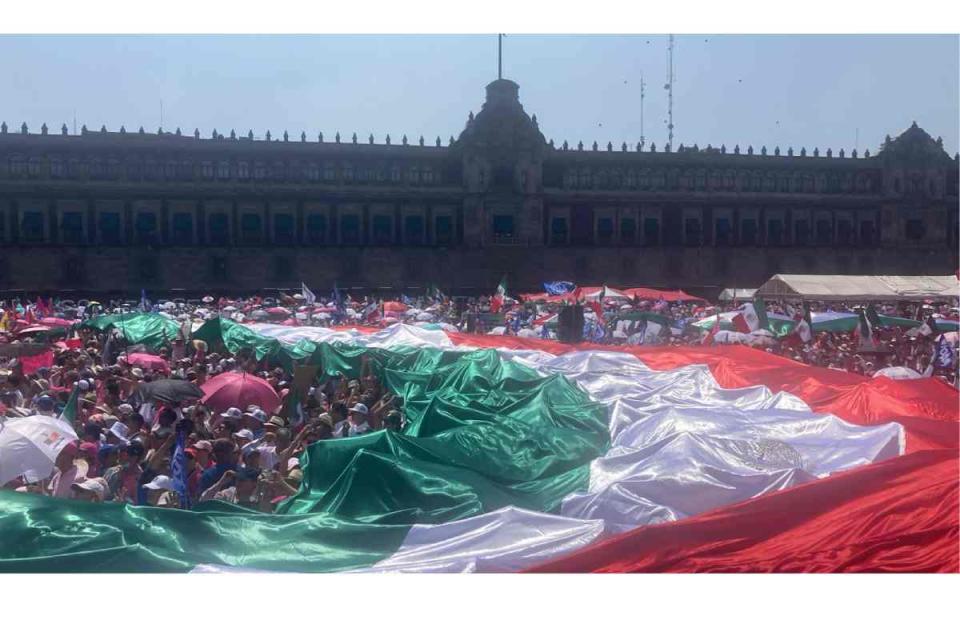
(0, 80, 958, 293)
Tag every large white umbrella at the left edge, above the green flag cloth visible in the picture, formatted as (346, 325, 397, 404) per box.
(0, 416, 77, 485)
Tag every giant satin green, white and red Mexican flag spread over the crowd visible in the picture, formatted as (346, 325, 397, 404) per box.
(0, 320, 958, 572)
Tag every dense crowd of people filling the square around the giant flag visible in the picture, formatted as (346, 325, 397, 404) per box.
(0, 284, 957, 512)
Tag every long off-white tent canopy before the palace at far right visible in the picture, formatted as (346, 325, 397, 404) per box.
(755, 273, 960, 302)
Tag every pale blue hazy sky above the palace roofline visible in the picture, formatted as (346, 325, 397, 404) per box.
(0, 35, 960, 155)
